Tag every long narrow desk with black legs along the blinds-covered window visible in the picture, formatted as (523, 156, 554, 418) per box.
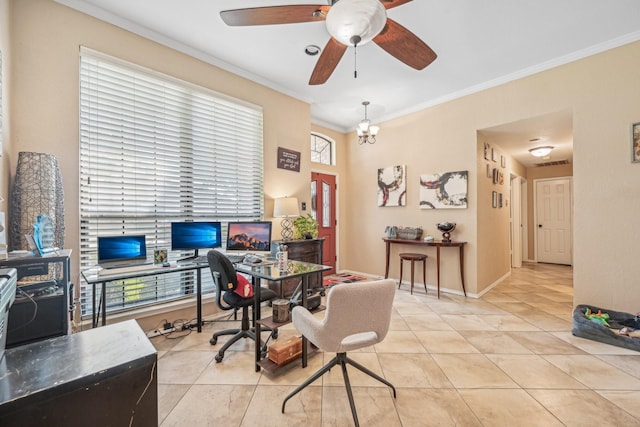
(81, 262, 209, 332)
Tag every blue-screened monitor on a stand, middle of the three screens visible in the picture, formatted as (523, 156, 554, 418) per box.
(171, 221, 222, 257)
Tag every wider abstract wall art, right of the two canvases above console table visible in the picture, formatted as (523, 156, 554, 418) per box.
(420, 171, 468, 209)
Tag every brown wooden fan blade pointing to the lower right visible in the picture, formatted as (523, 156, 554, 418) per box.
(373, 18, 438, 70)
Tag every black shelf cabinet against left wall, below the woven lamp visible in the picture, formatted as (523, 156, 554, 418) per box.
(0, 249, 71, 348)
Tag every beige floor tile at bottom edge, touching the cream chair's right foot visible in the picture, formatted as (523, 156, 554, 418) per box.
(396, 388, 482, 427)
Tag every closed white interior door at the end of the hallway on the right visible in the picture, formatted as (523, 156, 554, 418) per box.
(535, 178, 573, 265)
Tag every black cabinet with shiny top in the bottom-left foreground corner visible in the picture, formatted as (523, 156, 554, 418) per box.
(0, 320, 158, 427)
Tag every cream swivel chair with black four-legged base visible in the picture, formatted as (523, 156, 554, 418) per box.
(282, 279, 396, 426)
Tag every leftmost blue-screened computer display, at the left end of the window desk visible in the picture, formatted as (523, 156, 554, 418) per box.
(98, 234, 147, 268)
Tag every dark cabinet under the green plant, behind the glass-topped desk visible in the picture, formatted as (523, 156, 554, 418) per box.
(269, 239, 324, 298)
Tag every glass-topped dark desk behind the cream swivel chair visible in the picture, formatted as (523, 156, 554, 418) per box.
(235, 261, 331, 372)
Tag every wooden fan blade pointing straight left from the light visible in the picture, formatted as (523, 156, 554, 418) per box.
(220, 4, 331, 26)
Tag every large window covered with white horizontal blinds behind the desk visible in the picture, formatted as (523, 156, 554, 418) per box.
(80, 48, 264, 317)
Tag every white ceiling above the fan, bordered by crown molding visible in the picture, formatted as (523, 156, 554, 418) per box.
(56, 0, 640, 166)
